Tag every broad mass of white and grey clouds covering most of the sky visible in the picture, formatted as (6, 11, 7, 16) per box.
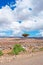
(0, 0, 43, 35)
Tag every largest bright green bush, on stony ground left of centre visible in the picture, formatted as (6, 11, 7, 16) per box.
(8, 44, 25, 55)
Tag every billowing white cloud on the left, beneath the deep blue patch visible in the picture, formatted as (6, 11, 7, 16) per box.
(0, 5, 20, 35)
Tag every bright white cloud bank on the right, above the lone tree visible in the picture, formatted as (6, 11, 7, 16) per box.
(21, 18, 43, 30)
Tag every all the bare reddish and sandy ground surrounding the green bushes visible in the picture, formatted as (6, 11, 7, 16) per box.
(0, 38, 43, 65)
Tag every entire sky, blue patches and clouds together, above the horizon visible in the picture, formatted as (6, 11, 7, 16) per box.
(0, 0, 43, 37)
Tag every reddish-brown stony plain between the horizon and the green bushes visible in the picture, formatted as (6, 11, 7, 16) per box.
(0, 38, 43, 53)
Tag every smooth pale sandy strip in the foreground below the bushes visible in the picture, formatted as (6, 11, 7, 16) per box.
(0, 52, 43, 65)
